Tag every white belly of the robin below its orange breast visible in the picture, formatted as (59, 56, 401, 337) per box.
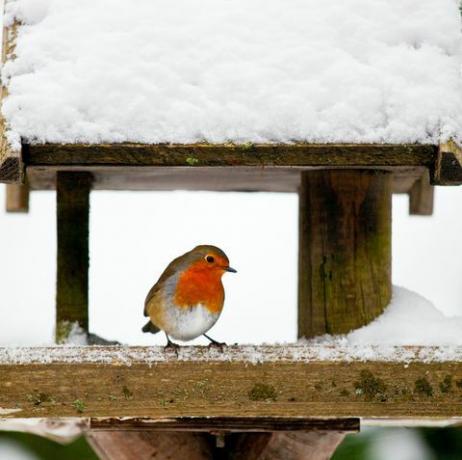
(164, 304, 220, 340)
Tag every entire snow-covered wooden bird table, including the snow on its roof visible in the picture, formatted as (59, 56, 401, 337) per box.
(0, 0, 462, 459)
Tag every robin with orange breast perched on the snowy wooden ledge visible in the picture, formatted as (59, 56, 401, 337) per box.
(142, 245, 236, 347)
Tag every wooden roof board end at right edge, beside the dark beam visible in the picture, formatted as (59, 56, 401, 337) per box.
(431, 140, 462, 185)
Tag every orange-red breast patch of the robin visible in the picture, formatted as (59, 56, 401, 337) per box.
(175, 267, 225, 313)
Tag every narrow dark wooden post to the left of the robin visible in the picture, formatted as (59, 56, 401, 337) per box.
(56, 172, 92, 343)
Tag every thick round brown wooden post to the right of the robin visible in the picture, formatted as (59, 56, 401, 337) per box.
(298, 170, 391, 337)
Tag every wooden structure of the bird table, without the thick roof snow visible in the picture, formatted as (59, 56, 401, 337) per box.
(0, 9, 462, 460)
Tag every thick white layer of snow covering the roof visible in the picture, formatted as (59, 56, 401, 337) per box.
(2, 0, 462, 143)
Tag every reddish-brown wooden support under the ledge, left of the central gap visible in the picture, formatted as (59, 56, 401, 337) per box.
(86, 431, 212, 460)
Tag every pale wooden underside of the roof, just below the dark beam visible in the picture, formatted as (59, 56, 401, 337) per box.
(27, 166, 426, 193)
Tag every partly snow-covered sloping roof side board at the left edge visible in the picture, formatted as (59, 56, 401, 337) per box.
(0, 20, 24, 183)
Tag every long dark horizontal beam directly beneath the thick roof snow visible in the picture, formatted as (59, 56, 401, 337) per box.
(24, 143, 437, 168)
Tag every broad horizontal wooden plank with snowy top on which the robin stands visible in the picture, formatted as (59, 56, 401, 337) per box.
(0, 345, 462, 423)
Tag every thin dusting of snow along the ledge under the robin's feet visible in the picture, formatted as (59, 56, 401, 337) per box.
(0, 344, 462, 366)
